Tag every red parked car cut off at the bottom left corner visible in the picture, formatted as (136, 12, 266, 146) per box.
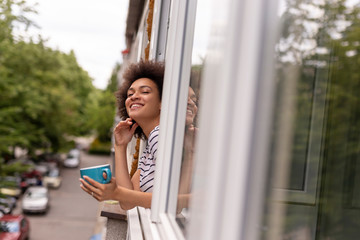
(0, 215, 30, 240)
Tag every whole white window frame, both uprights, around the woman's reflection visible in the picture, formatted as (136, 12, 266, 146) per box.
(132, 0, 277, 240)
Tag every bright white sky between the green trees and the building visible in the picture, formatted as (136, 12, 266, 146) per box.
(27, 0, 129, 89)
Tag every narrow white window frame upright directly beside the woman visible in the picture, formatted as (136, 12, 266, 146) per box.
(151, 0, 196, 225)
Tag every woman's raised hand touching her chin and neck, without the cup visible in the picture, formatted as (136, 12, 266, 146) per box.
(114, 118, 139, 146)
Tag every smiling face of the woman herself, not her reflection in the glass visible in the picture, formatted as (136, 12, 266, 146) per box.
(125, 78, 161, 125)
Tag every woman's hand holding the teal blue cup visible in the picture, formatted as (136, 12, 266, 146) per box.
(79, 176, 117, 202)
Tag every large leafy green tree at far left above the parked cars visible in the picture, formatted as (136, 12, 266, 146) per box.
(0, 0, 108, 158)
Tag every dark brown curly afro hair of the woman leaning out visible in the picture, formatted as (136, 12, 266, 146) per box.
(115, 60, 165, 139)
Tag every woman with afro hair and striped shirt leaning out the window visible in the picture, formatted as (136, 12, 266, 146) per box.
(80, 61, 164, 210)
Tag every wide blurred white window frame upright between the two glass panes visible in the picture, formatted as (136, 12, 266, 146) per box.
(189, 0, 278, 240)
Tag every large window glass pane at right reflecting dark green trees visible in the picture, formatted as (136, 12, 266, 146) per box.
(262, 0, 360, 237)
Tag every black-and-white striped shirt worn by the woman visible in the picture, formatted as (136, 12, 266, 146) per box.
(138, 126, 159, 192)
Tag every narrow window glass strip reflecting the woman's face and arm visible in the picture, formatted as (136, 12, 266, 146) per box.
(176, 0, 211, 235)
